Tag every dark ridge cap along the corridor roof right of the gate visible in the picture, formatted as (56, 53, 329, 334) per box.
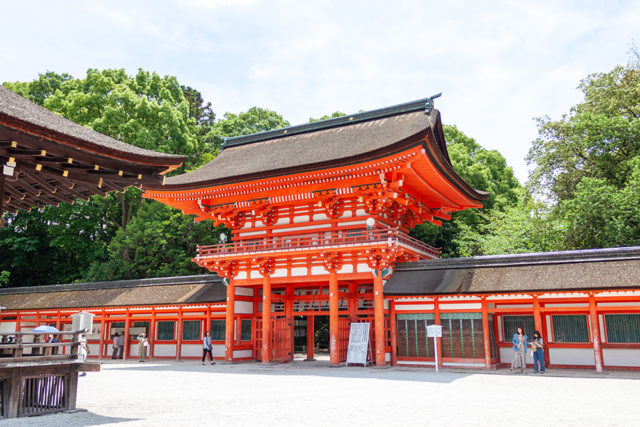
(396, 246, 640, 271)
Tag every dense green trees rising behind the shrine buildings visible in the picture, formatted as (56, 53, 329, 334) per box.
(5, 55, 640, 286)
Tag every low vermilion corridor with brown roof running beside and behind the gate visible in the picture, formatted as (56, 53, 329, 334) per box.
(0, 247, 640, 370)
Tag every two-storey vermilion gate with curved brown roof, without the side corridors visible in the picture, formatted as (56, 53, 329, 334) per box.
(145, 98, 487, 366)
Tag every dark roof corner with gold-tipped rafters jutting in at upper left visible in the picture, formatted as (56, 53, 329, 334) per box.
(0, 86, 184, 214)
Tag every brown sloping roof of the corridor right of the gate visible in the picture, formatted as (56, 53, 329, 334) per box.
(384, 247, 640, 296)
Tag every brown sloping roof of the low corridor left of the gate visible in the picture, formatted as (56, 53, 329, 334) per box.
(0, 275, 226, 310)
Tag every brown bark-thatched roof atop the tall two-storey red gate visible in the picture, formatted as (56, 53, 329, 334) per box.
(152, 98, 487, 201)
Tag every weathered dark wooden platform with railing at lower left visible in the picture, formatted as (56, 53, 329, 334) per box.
(0, 330, 100, 418)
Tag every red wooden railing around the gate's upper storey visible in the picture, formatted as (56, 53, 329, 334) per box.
(196, 228, 441, 259)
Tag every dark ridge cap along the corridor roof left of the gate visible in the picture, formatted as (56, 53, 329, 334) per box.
(0, 274, 222, 295)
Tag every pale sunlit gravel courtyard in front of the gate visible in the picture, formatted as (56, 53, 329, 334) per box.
(5, 361, 640, 426)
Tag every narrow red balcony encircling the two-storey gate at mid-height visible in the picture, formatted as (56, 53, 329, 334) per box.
(194, 229, 441, 263)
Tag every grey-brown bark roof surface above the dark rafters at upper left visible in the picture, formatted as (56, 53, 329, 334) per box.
(0, 85, 185, 167)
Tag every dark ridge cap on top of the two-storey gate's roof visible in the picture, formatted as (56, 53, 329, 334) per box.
(222, 96, 436, 149)
